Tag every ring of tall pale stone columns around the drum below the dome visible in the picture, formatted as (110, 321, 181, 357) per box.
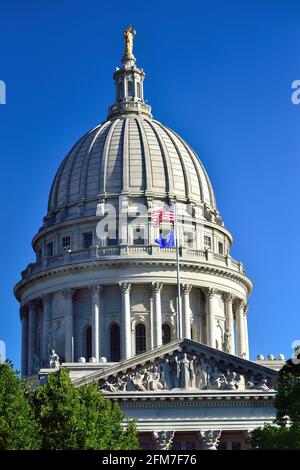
(21, 281, 249, 376)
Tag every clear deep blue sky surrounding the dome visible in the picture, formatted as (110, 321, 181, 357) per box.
(0, 0, 300, 366)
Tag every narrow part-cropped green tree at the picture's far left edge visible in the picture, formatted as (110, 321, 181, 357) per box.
(0, 361, 40, 450)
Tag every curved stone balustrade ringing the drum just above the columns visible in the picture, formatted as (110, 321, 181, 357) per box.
(22, 245, 245, 279)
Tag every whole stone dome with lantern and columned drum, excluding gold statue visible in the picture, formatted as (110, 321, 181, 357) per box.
(14, 33, 252, 376)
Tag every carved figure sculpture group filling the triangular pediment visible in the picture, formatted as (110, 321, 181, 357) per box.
(99, 351, 274, 393)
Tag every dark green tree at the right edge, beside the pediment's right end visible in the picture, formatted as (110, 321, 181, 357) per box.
(250, 360, 300, 449)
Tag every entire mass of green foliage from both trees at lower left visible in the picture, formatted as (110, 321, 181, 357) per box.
(0, 364, 139, 450)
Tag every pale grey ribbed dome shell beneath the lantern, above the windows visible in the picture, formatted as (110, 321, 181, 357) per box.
(48, 114, 216, 213)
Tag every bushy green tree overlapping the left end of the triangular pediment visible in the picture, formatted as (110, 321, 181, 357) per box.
(34, 369, 138, 450)
